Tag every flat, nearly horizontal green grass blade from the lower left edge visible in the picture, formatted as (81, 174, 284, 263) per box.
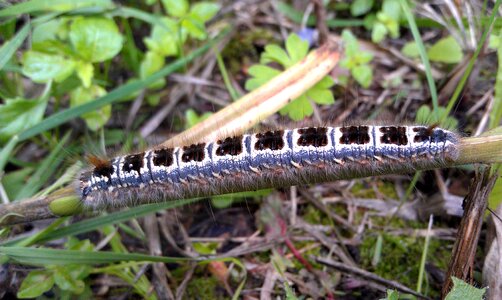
(0, 247, 192, 265)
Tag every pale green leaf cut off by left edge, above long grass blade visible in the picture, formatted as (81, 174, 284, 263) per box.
(0, 98, 47, 143)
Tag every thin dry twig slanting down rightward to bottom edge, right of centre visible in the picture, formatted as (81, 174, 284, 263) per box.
(314, 257, 429, 299)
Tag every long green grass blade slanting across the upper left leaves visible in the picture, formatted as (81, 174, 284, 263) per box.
(19, 30, 229, 141)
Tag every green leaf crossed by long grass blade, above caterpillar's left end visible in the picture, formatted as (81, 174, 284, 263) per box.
(70, 85, 111, 131)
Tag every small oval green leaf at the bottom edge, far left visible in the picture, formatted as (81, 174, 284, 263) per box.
(17, 270, 54, 299)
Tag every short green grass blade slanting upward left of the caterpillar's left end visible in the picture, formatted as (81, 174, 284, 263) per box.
(16, 132, 71, 200)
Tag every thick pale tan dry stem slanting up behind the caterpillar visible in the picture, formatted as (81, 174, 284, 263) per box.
(161, 42, 340, 147)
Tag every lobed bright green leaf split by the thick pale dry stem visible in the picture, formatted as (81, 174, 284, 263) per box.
(245, 34, 335, 121)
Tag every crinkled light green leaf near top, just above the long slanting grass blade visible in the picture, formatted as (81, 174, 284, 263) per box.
(144, 18, 186, 56)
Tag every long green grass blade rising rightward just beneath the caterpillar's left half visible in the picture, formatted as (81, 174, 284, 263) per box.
(0, 198, 201, 246)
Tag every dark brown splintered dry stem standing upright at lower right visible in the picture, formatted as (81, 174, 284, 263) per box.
(441, 168, 498, 299)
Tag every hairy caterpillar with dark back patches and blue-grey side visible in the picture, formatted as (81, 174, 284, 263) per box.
(77, 125, 459, 208)
